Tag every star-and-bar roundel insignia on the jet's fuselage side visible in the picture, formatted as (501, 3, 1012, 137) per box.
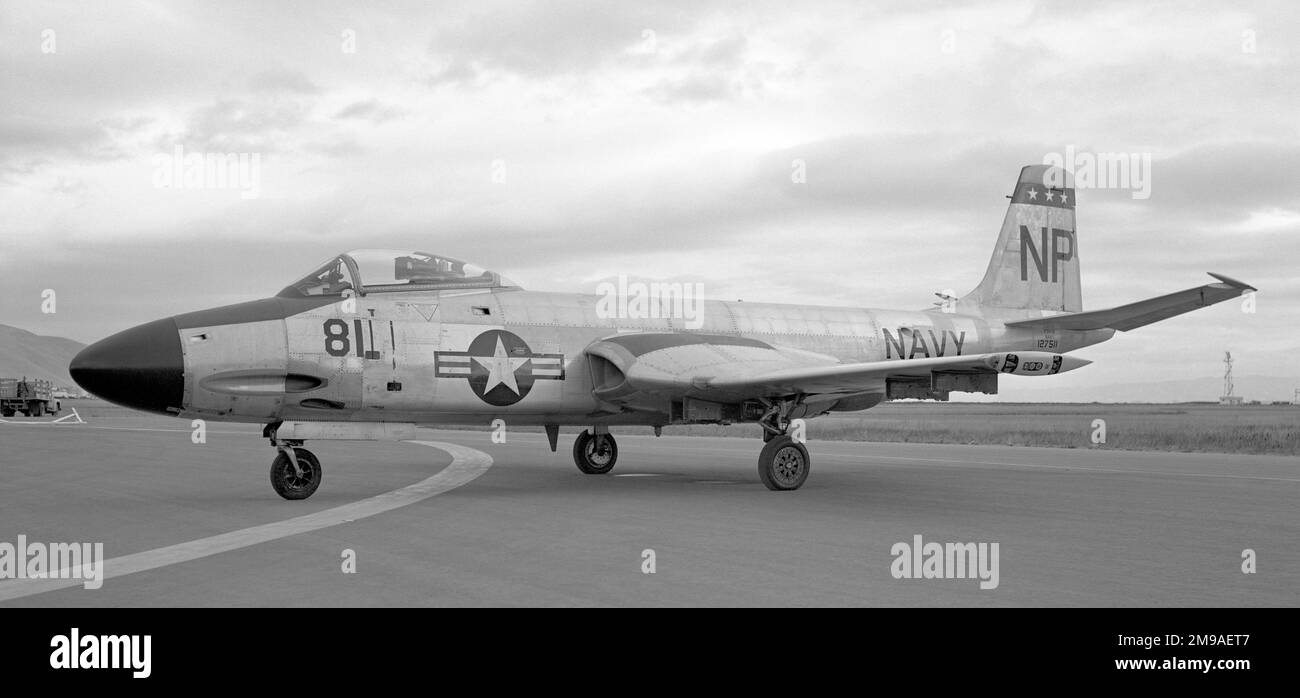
(433, 330, 564, 407)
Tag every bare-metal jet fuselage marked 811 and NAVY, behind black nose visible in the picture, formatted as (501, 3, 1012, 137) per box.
(139, 289, 1113, 425)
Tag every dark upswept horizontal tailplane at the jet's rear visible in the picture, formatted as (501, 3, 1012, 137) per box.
(1006, 273, 1255, 331)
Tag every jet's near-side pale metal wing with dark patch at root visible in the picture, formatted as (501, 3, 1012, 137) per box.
(586, 333, 1091, 403)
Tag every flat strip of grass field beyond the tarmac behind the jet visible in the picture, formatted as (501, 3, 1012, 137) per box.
(20, 400, 1300, 455)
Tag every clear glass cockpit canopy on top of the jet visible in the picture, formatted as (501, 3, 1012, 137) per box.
(280, 250, 519, 296)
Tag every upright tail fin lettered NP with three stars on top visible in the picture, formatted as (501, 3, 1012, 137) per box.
(962, 165, 1083, 316)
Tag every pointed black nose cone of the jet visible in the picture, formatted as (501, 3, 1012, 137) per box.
(69, 317, 185, 415)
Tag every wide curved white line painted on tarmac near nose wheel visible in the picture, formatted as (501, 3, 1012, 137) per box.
(0, 441, 493, 601)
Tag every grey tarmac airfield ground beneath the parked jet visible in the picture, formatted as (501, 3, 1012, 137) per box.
(0, 400, 1300, 607)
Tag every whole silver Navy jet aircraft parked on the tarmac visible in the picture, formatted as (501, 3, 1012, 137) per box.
(70, 165, 1253, 499)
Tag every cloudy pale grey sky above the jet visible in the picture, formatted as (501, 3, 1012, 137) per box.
(0, 0, 1300, 395)
